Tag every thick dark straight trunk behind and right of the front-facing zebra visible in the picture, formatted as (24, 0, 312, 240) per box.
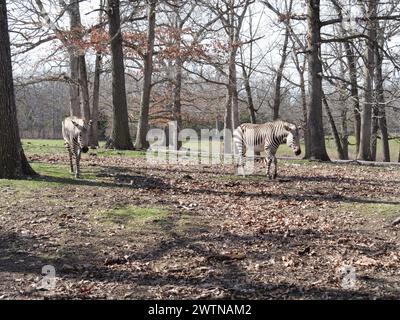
(108, 0, 133, 150)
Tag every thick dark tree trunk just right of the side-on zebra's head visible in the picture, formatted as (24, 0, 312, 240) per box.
(307, 0, 330, 161)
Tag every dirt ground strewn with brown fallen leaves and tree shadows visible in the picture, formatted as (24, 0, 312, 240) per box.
(0, 155, 400, 299)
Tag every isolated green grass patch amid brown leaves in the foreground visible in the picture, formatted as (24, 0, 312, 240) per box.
(100, 206, 170, 227)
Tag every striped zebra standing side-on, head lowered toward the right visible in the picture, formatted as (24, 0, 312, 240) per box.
(233, 120, 301, 179)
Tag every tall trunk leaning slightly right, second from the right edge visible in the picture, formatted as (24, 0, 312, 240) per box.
(358, 0, 376, 161)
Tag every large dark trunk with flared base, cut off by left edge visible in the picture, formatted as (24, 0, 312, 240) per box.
(0, 0, 35, 179)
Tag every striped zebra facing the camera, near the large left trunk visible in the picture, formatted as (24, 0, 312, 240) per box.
(62, 117, 92, 178)
